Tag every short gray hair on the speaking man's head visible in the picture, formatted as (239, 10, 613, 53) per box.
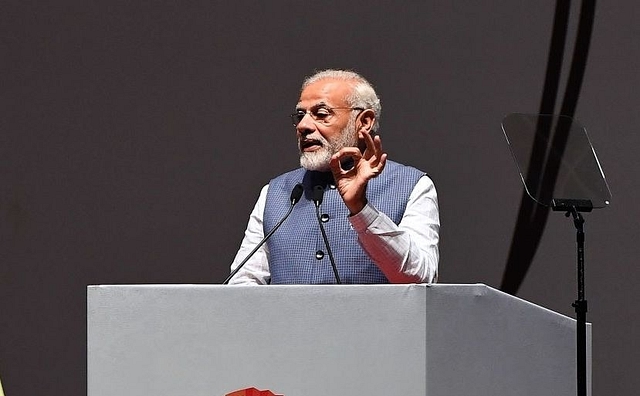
(301, 69, 382, 133)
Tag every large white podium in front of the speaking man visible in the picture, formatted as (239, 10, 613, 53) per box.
(87, 285, 591, 396)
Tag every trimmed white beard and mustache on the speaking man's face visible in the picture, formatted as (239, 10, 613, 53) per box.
(298, 119, 358, 172)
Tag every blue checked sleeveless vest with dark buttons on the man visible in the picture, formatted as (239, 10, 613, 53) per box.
(263, 161, 424, 284)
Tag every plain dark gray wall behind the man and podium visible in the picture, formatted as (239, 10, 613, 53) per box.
(0, 0, 640, 396)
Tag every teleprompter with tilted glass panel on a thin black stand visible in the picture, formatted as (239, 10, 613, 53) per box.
(502, 113, 611, 396)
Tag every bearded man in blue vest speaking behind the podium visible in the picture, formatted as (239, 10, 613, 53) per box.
(228, 70, 440, 285)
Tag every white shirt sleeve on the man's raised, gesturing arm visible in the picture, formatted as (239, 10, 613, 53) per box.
(349, 176, 440, 283)
